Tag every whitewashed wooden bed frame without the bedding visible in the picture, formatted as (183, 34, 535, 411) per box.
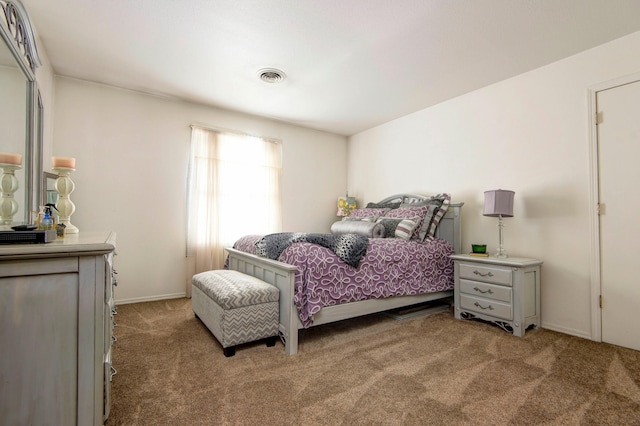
(226, 194, 464, 355)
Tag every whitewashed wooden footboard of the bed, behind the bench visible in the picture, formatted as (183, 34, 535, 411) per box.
(226, 248, 300, 355)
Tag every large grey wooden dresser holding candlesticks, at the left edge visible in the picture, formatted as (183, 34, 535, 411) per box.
(0, 232, 117, 426)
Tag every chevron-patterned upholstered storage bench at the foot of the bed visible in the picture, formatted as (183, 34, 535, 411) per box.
(191, 270, 280, 357)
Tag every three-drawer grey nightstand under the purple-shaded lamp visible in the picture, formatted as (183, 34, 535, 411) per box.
(451, 254, 542, 337)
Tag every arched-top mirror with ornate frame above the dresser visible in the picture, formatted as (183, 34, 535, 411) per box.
(0, 0, 42, 224)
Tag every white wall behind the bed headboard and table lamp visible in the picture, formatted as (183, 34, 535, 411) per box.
(348, 32, 640, 337)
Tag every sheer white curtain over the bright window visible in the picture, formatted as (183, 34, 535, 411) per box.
(187, 125, 282, 295)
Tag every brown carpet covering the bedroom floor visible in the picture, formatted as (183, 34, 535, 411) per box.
(107, 299, 640, 426)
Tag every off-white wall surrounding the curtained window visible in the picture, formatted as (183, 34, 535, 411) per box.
(52, 77, 347, 303)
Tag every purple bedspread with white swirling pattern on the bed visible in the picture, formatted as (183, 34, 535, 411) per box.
(233, 235, 453, 327)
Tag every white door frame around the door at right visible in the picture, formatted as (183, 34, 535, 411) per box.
(587, 72, 640, 342)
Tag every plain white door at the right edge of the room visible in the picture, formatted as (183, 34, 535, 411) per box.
(596, 81, 640, 350)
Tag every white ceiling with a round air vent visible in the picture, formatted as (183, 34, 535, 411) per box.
(22, 0, 640, 135)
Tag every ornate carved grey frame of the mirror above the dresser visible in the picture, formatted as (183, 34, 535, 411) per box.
(0, 0, 43, 223)
